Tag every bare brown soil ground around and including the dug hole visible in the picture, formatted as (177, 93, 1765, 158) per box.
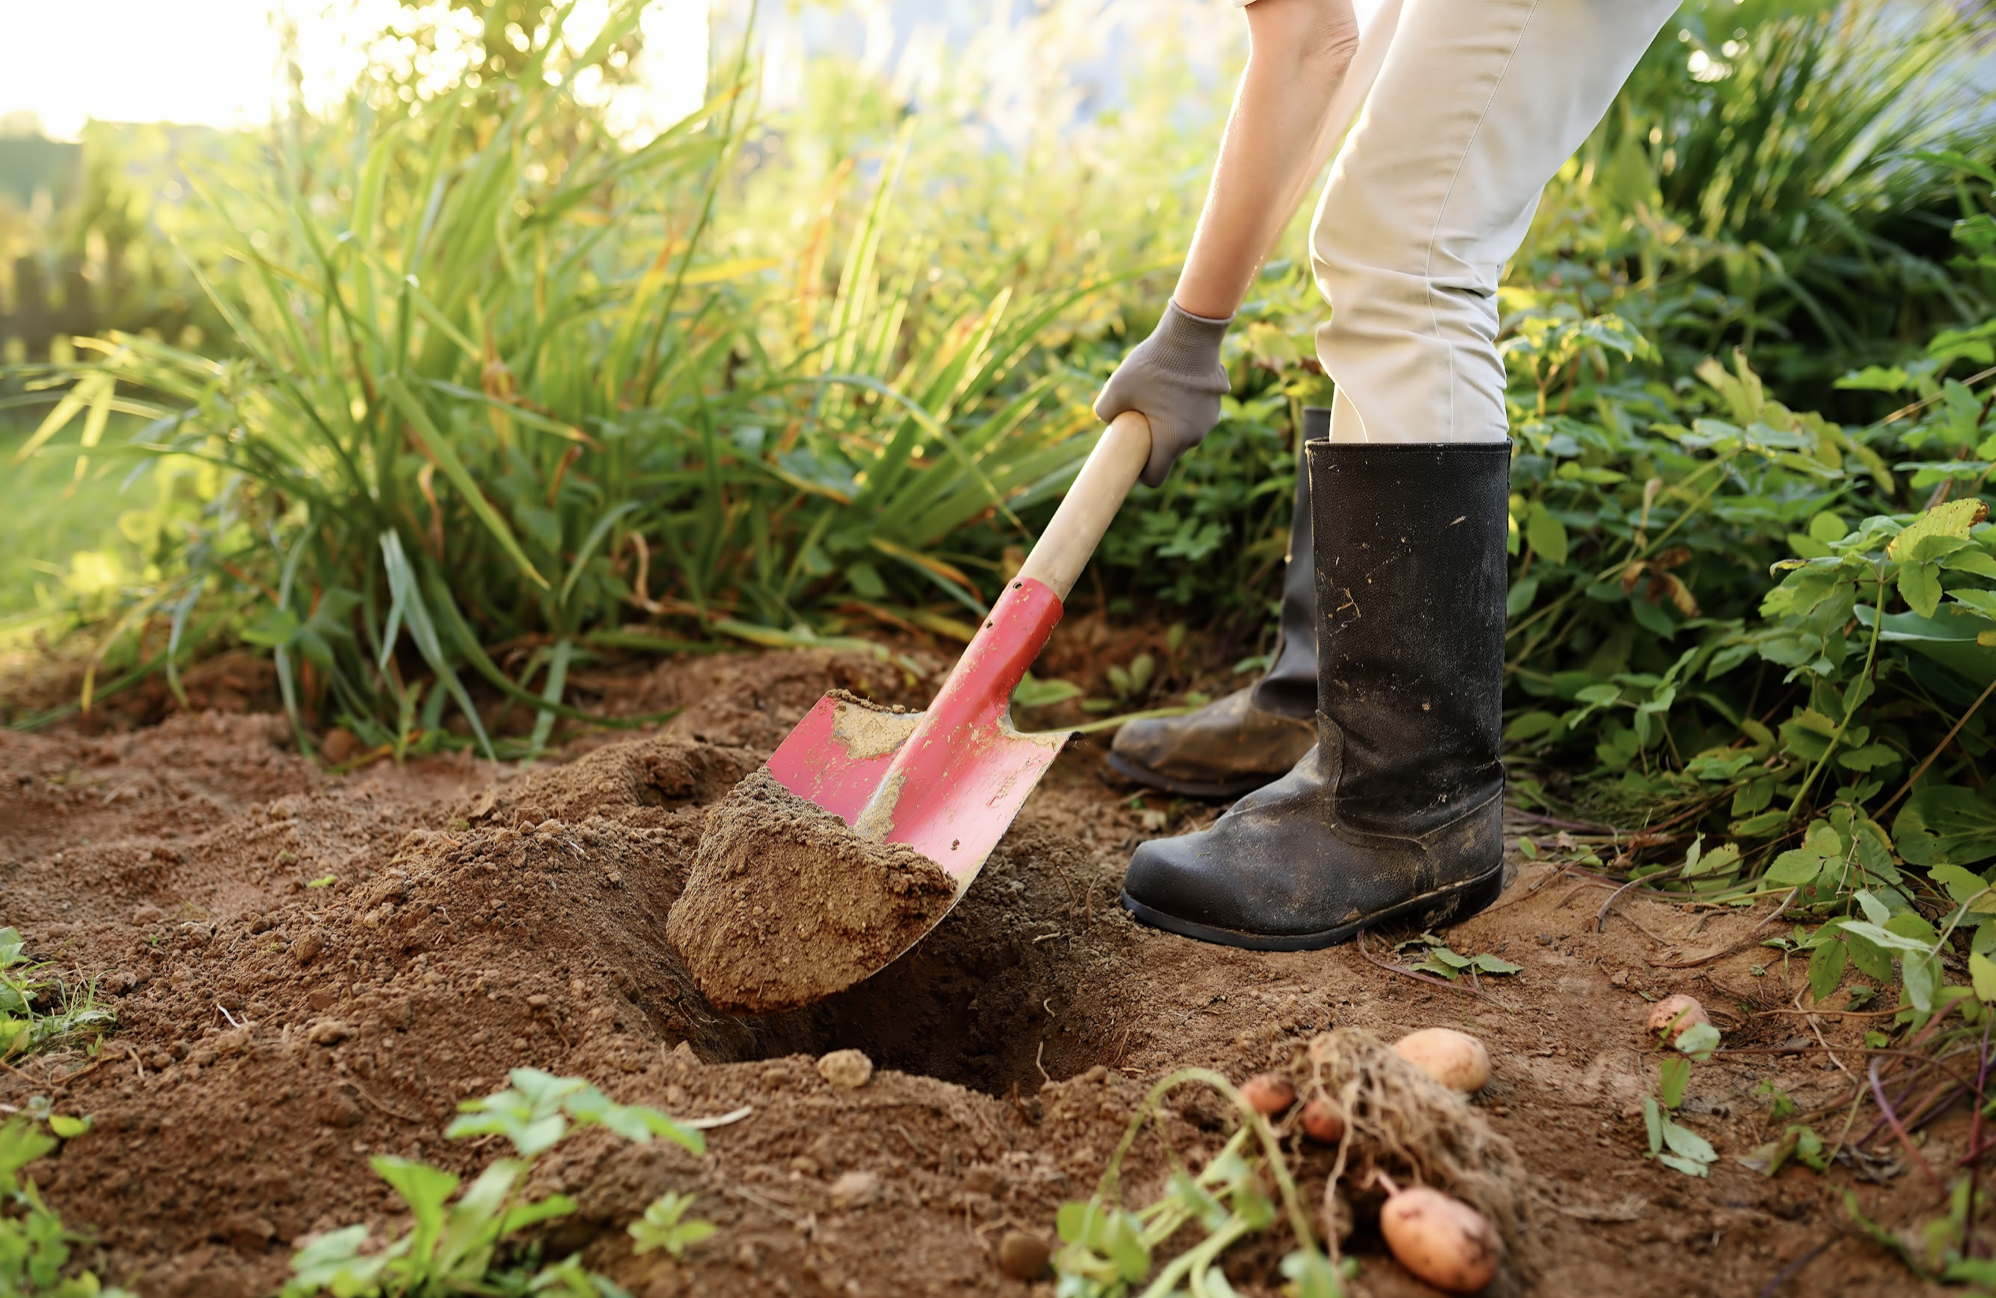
(0, 653, 1968, 1298)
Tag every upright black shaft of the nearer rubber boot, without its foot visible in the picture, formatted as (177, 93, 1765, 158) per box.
(1305, 441, 1511, 835)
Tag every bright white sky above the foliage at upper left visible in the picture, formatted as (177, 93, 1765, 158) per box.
(0, 0, 707, 140)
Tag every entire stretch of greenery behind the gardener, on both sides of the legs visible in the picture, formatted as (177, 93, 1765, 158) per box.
(0, 0, 1996, 890)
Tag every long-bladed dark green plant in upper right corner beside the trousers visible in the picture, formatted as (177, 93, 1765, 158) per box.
(1519, 0, 1996, 407)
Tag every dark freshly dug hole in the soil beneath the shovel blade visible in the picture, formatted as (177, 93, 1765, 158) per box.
(662, 825, 1138, 1094)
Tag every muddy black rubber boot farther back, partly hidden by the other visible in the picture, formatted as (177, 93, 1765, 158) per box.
(1110, 405, 1331, 797)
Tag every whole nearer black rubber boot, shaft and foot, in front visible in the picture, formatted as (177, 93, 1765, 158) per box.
(1122, 441, 1511, 951)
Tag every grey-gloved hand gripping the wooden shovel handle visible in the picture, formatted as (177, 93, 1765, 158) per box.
(1096, 302, 1234, 487)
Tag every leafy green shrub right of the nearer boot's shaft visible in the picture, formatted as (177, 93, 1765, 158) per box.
(1507, 174, 1996, 958)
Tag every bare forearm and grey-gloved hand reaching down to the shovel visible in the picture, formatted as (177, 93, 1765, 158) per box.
(1096, 0, 1359, 487)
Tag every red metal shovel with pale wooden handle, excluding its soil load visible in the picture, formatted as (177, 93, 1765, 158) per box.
(768, 411, 1150, 894)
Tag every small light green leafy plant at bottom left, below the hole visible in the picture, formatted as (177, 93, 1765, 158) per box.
(283, 1068, 713, 1298)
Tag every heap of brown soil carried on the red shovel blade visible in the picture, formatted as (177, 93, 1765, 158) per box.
(665, 767, 956, 1014)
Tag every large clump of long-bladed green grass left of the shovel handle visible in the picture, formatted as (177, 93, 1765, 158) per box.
(16, 2, 1086, 755)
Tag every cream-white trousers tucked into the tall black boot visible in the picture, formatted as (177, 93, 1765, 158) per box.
(1309, 0, 1677, 441)
